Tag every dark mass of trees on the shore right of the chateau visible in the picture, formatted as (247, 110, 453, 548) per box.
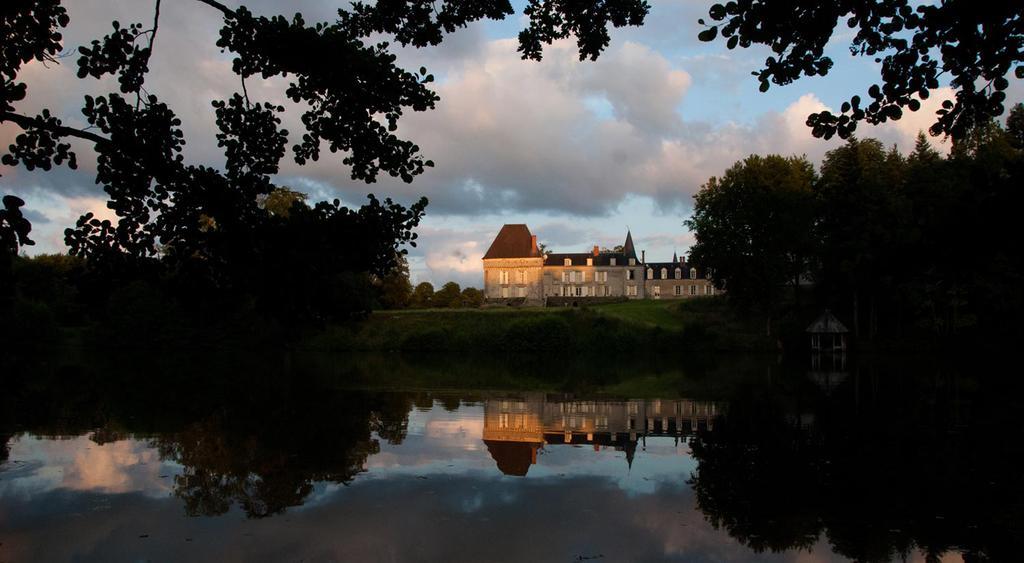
(686, 104, 1024, 339)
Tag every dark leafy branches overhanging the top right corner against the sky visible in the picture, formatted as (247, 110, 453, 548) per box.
(699, 0, 1024, 138)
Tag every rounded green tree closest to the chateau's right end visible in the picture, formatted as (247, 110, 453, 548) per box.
(686, 155, 815, 335)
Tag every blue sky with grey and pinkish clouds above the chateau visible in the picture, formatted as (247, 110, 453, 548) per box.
(0, 0, 1024, 287)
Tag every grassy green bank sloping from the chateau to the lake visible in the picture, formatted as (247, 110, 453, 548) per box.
(304, 298, 775, 353)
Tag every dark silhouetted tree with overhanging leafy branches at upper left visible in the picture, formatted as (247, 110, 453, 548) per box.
(0, 0, 646, 317)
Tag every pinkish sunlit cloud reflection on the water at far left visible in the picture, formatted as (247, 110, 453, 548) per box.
(0, 436, 179, 496)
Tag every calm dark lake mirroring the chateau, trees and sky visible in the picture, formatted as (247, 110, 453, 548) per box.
(0, 353, 1024, 562)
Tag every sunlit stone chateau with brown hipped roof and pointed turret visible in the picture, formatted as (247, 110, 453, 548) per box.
(483, 224, 716, 305)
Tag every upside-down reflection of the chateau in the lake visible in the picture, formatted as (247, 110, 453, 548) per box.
(483, 393, 719, 476)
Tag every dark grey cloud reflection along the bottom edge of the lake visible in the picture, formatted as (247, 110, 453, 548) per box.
(3, 472, 838, 562)
